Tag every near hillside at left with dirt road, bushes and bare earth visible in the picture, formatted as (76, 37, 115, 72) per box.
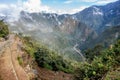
(0, 22, 74, 80)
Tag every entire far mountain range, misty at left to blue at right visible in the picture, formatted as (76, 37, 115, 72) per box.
(0, 1, 120, 60)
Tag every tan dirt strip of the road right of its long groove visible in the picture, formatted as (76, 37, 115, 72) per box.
(10, 37, 29, 80)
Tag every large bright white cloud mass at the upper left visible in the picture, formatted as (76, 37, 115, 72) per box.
(0, 0, 53, 21)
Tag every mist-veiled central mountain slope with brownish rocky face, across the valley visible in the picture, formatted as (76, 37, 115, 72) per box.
(9, 11, 96, 59)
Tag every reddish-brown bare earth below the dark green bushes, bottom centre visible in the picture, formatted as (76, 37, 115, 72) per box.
(37, 68, 73, 80)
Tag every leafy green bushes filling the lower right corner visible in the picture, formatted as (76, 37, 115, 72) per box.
(75, 40, 120, 80)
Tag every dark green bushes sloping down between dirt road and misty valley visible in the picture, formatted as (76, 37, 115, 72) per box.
(23, 37, 74, 73)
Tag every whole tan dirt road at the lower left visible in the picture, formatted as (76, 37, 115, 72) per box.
(0, 35, 29, 80)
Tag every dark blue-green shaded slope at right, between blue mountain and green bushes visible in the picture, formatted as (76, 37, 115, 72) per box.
(80, 26, 120, 49)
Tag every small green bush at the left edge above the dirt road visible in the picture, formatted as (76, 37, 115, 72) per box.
(0, 21, 9, 38)
